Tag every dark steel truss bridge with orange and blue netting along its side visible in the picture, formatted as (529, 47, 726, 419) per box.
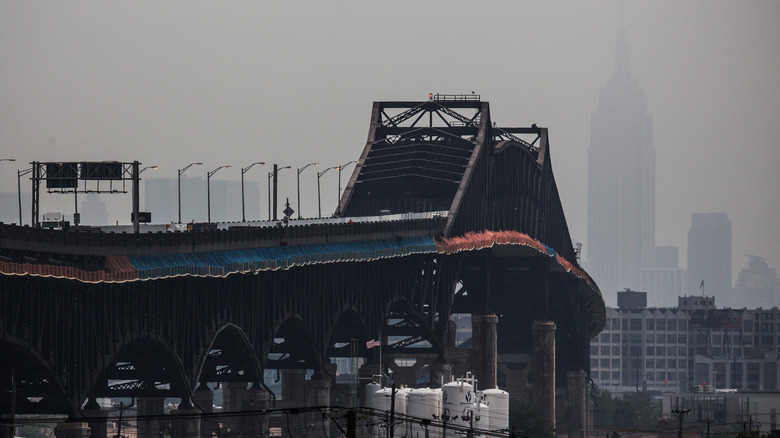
(0, 95, 605, 436)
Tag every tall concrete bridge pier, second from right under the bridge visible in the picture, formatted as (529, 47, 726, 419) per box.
(531, 321, 556, 431)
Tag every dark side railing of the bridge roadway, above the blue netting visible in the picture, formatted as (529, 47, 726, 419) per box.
(0, 217, 446, 258)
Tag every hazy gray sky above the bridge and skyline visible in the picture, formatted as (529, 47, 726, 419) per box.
(0, 0, 780, 281)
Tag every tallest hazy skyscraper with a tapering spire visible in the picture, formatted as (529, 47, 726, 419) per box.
(587, 31, 655, 305)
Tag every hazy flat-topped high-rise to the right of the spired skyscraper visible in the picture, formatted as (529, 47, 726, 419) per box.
(686, 213, 732, 306)
